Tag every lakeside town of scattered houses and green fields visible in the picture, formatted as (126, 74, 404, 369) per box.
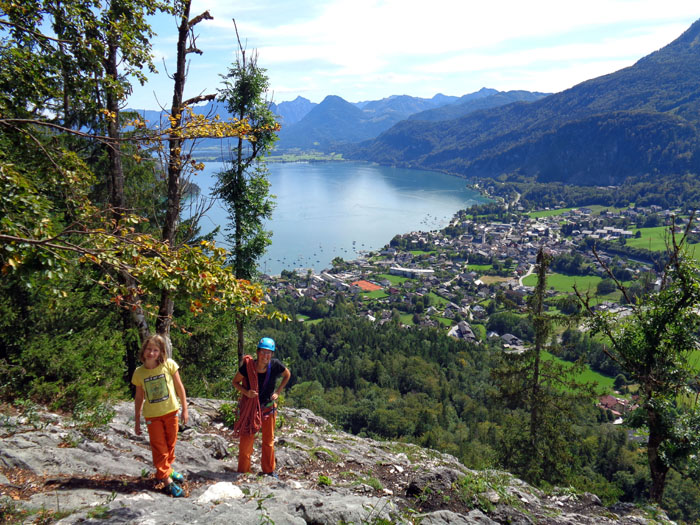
(263, 186, 698, 423)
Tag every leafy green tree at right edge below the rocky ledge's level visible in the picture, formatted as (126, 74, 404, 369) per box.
(577, 220, 700, 503)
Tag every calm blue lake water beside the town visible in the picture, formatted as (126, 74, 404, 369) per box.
(194, 162, 483, 275)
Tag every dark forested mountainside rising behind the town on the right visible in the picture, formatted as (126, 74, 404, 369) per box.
(347, 18, 700, 185)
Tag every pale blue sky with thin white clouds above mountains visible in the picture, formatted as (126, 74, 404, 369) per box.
(128, 0, 700, 109)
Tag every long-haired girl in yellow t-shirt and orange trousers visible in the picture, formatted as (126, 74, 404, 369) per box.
(131, 335, 188, 498)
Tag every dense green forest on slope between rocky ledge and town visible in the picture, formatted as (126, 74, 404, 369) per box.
(253, 317, 700, 523)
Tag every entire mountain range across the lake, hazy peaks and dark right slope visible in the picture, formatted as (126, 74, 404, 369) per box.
(130, 21, 700, 185)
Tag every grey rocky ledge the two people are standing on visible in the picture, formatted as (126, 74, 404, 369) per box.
(0, 399, 672, 525)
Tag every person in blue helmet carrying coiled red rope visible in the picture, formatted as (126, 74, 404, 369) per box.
(233, 337, 292, 477)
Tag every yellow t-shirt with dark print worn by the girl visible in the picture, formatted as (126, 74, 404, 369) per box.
(131, 359, 180, 417)
